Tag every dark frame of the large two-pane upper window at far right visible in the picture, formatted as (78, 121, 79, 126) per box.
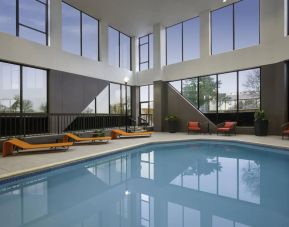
(210, 0, 260, 55)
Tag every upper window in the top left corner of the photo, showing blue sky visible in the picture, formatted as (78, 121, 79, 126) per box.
(0, 0, 48, 45)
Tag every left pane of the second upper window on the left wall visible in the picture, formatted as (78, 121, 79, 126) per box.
(62, 3, 80, 55)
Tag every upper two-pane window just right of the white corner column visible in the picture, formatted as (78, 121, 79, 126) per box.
(166, 17, 200, 65)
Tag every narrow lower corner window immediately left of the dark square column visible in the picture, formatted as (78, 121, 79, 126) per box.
(140, 85, 154, 125)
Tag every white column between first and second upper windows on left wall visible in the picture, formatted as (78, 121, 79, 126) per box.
(49, 0, 62, 50)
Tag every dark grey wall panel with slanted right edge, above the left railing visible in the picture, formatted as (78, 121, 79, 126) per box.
(49, 70, 109, 113)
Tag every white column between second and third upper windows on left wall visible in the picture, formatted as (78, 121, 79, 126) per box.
(99, 21, 108, 64)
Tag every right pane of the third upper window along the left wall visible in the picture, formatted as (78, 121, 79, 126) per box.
(120, 33, 130, 70)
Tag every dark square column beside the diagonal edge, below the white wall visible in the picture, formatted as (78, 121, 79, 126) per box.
(154, 81, 168, 132)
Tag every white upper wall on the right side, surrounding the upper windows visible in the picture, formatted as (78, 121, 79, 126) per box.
(137, 0, 289, 85)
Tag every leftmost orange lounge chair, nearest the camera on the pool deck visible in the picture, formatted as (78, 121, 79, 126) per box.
(2, 139, 73, 157)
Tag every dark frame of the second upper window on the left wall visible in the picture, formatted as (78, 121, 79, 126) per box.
(61, 0, 100, 61)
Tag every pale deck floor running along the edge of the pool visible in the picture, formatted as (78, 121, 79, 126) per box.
(0, 133, 289, 179)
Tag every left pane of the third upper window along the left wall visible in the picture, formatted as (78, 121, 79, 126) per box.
(108, 27, 119, 67)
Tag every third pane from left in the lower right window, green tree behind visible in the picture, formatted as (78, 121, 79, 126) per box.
(199, 75, 217, 113)
